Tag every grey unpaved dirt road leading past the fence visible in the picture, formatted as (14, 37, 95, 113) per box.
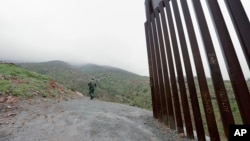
(0, 97, 191, 141)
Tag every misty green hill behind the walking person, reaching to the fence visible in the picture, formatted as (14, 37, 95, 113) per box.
(18, 61, 151, 109)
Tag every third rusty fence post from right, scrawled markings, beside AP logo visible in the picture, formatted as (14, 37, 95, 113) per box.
(193, 0, 238, 139)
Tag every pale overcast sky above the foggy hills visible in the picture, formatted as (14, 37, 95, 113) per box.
(0, 0, 250, 76)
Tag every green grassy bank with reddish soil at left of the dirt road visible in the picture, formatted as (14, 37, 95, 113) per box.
(0, 62, 73, 98)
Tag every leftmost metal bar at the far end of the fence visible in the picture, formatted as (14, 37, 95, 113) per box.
(144, 22, 157, 118)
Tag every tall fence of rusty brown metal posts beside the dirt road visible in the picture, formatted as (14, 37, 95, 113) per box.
(145, 0, 250, 140)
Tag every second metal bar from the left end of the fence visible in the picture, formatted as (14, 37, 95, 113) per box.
(148, 21, 162, 120)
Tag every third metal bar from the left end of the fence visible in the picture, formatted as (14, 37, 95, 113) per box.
(151, 13, 170, 126)
